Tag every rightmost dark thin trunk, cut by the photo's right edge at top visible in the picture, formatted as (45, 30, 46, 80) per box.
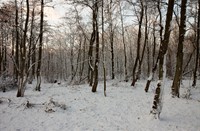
(192, 0, 200, 87)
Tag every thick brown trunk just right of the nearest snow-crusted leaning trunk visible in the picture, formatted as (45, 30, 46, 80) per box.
(172, 0, 187, 97)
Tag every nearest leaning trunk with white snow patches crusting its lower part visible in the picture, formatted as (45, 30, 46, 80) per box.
(151, 0, 174, 118)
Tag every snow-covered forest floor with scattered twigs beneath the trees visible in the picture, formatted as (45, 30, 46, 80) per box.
(0, 80, 200, 131)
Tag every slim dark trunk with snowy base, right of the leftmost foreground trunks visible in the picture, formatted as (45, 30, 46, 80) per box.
(35, 0, 44, 91)
